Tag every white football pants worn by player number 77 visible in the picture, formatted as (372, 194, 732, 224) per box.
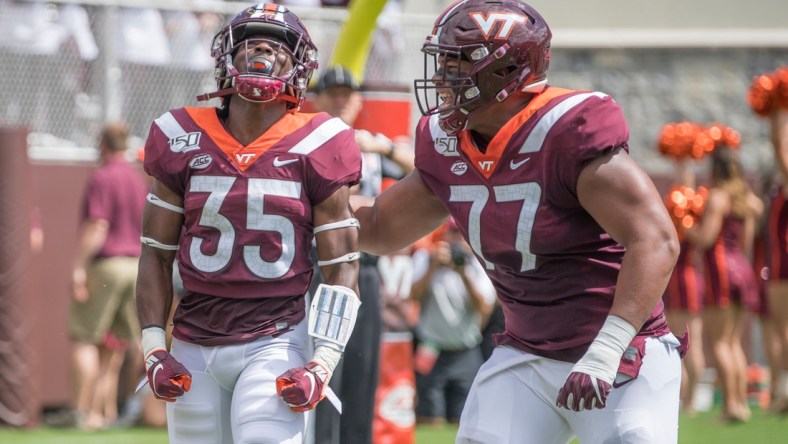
(457, 334, 681, 444)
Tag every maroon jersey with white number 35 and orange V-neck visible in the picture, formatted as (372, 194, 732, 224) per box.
(145, 108, 361, 344)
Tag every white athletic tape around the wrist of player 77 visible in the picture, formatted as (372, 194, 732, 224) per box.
(572, 315, 637, 384)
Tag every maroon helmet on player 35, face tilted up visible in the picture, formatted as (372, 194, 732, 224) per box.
(197, 3, 318, 108)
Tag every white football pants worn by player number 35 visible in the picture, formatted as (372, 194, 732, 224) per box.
(167, 321, 308, 444)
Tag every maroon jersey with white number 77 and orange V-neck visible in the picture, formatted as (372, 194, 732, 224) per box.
(416, 88, 667, 362)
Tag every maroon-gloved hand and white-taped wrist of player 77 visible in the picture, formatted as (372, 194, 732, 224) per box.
(556, 316, 637, 412)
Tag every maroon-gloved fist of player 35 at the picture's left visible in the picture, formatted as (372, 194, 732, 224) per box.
(145, 349, 192, 402)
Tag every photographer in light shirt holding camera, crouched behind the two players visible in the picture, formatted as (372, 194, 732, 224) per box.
(410, 219, 495, 425)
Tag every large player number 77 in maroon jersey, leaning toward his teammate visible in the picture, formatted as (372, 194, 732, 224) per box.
(351, 0, 681, 444)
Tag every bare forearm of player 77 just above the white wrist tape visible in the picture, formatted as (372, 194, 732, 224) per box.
(610, 241, 678, 330)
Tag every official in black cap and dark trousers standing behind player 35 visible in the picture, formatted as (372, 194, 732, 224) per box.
(312, 66, 413, 444)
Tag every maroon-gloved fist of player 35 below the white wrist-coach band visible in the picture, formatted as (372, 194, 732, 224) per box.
(276, 361, 328, 412)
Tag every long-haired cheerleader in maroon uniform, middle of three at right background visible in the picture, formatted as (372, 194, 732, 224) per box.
(685, 144, 763, 422)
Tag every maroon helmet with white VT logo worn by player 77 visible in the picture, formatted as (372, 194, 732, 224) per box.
(414, 0, 552, 134)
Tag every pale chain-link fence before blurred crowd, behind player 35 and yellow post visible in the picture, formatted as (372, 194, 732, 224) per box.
(0, 0, 428, 151)
